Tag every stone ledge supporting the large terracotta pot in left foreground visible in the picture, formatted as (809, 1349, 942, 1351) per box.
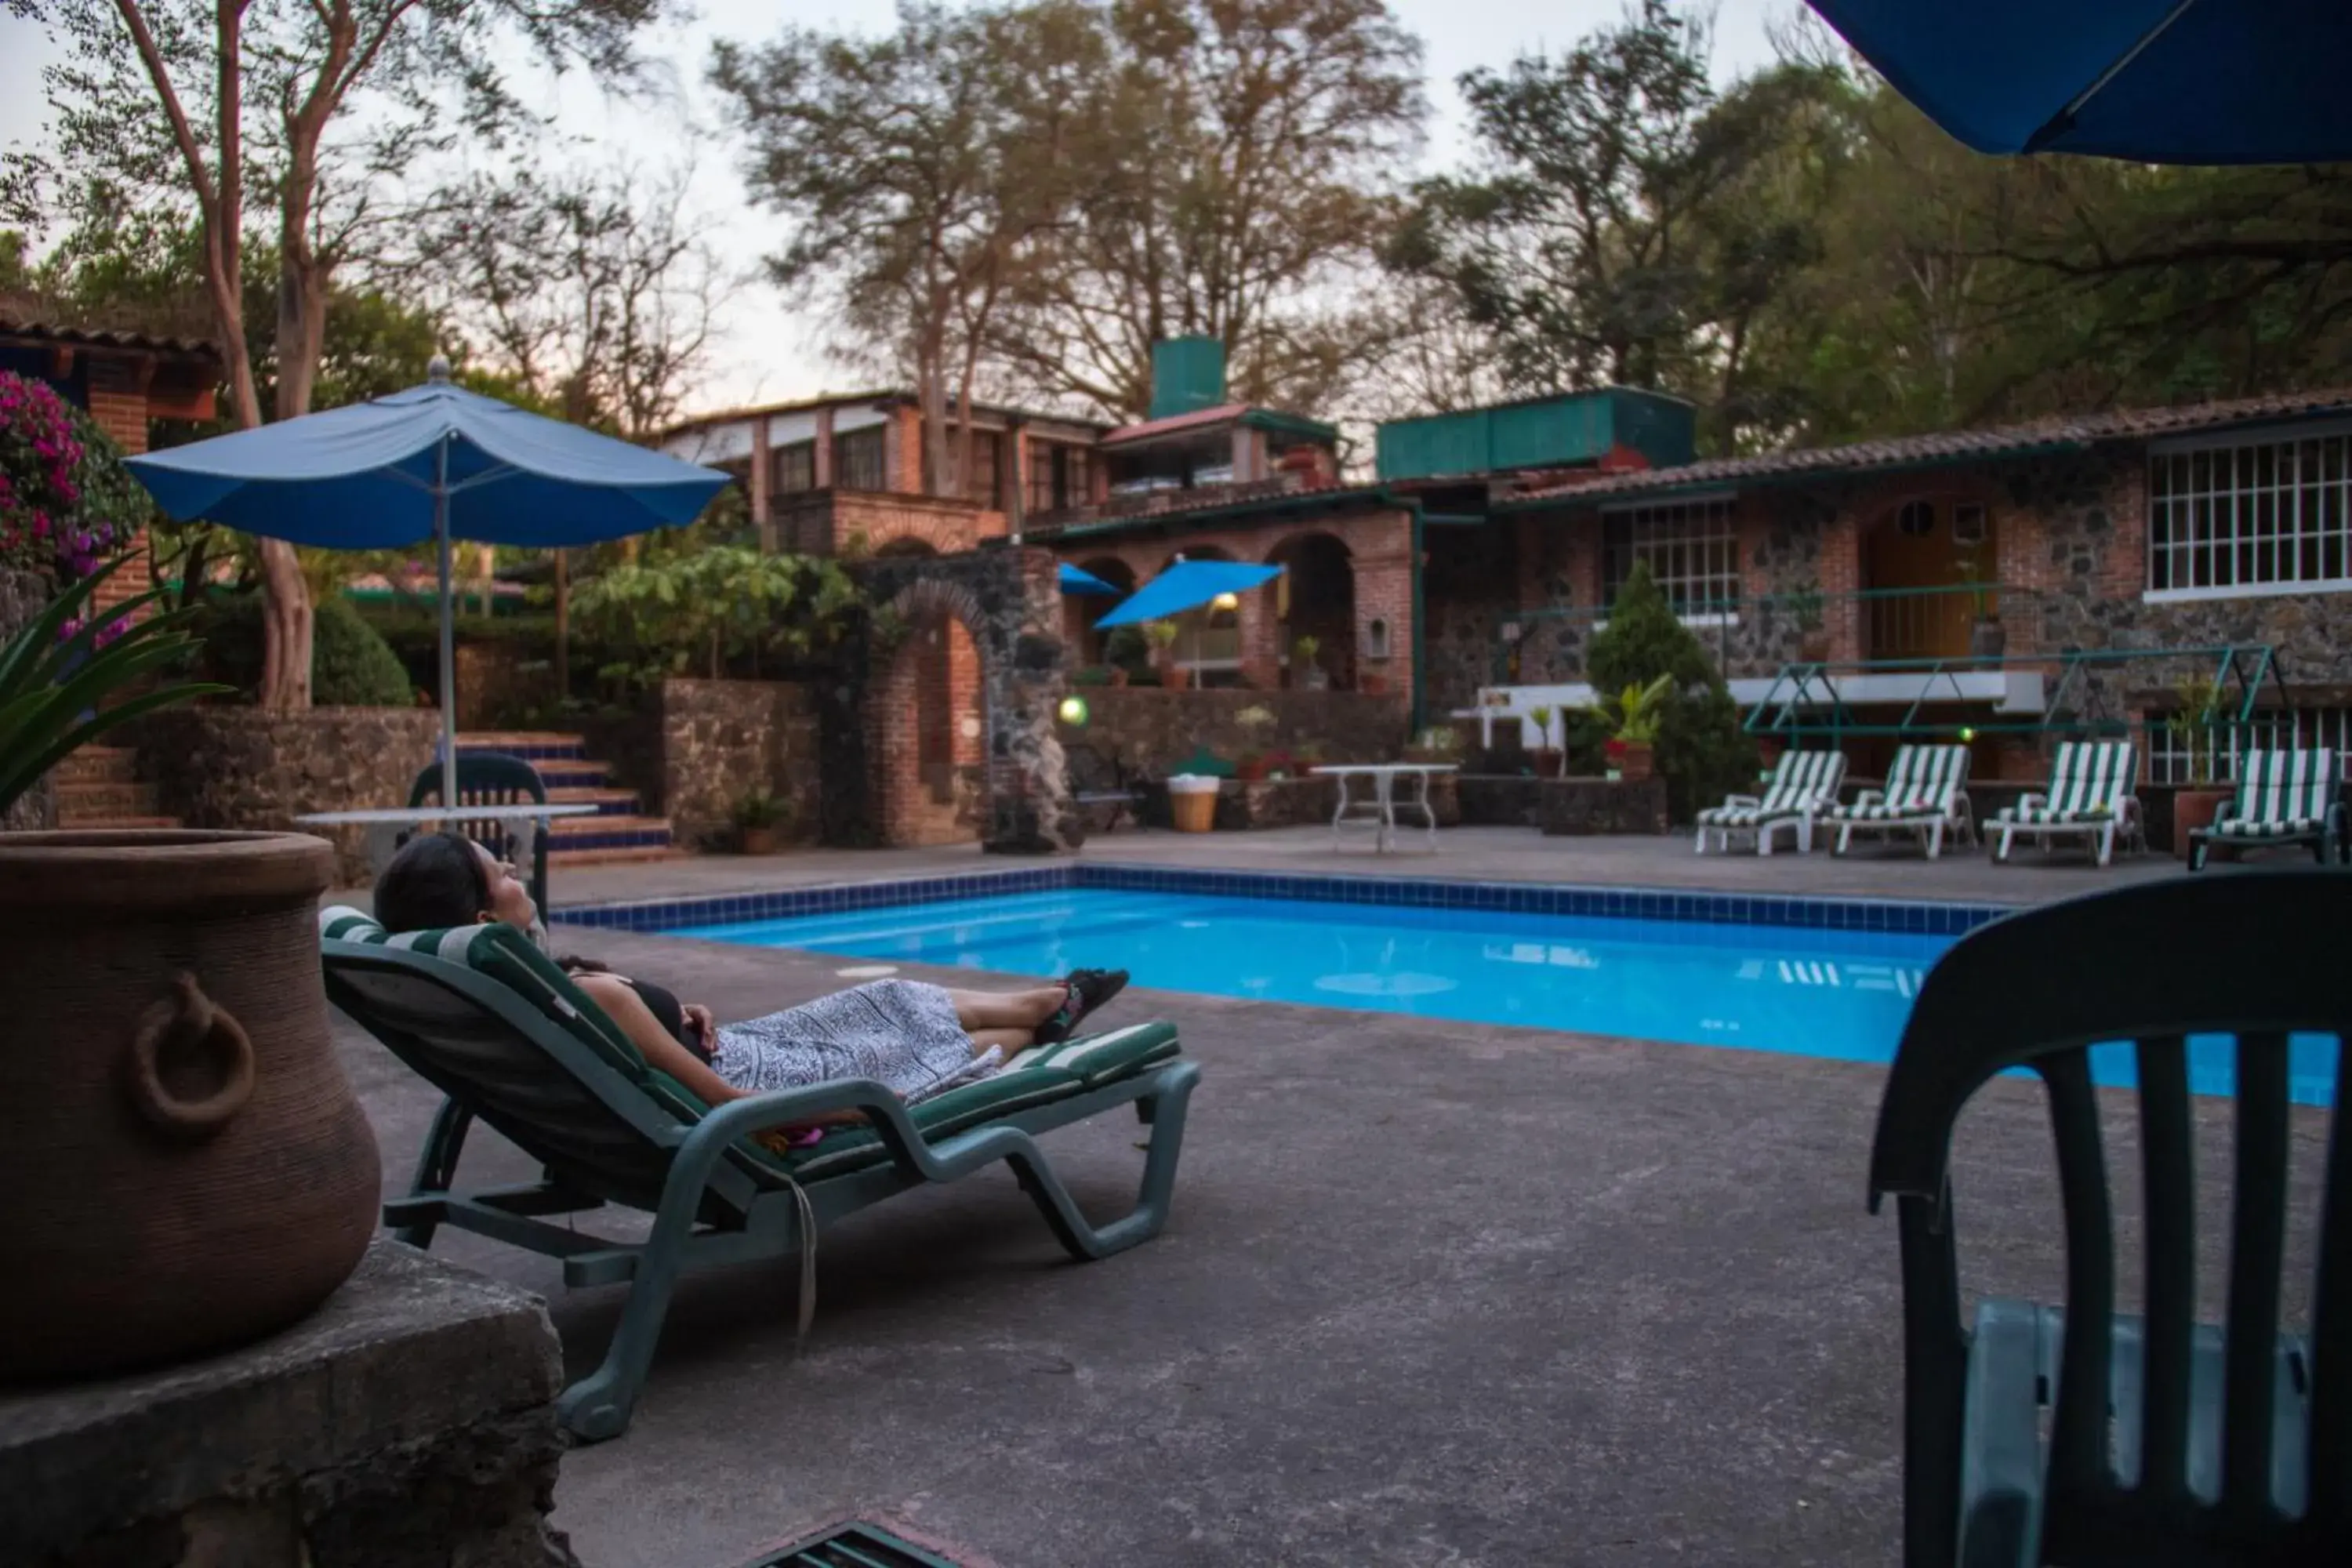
(0, 1239, 579, 1568)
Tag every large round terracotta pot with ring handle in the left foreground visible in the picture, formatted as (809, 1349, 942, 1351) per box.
(0, 832, 381, 1377)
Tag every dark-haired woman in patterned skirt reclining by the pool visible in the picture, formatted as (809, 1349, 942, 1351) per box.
(376, 832, 1127, 1121)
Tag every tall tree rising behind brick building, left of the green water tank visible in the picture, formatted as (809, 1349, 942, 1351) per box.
(710, 0, 1096, 494)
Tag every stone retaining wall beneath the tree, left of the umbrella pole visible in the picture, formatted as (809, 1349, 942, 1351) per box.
(129, 703, 440, 886)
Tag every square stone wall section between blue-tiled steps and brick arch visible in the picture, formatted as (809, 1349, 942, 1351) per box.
(661, 680, 821, 844)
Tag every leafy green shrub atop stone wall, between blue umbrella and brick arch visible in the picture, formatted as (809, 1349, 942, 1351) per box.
(572, 546, 866, 682)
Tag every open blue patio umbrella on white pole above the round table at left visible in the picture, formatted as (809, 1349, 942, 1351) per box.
(129, 360, 727, 801)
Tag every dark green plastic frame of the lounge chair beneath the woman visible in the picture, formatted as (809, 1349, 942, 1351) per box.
(320, 940, 1200, 1441)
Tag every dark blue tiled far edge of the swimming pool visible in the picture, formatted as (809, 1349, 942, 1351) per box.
(550, 860, 2013, 935)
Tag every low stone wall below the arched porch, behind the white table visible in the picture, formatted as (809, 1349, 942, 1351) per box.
(1061, 687, 1411, 779)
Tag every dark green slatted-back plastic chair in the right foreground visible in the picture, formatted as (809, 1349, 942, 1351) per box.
(1870, 869, 2352, 1568)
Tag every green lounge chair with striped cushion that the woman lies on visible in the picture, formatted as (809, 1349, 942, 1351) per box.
(320, 909, 1200, 1441)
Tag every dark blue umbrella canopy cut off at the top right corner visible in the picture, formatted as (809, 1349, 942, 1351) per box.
(1811, 0, 2352, 165)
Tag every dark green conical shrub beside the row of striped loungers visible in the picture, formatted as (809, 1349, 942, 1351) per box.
(1585, 564, 1755, 822)
